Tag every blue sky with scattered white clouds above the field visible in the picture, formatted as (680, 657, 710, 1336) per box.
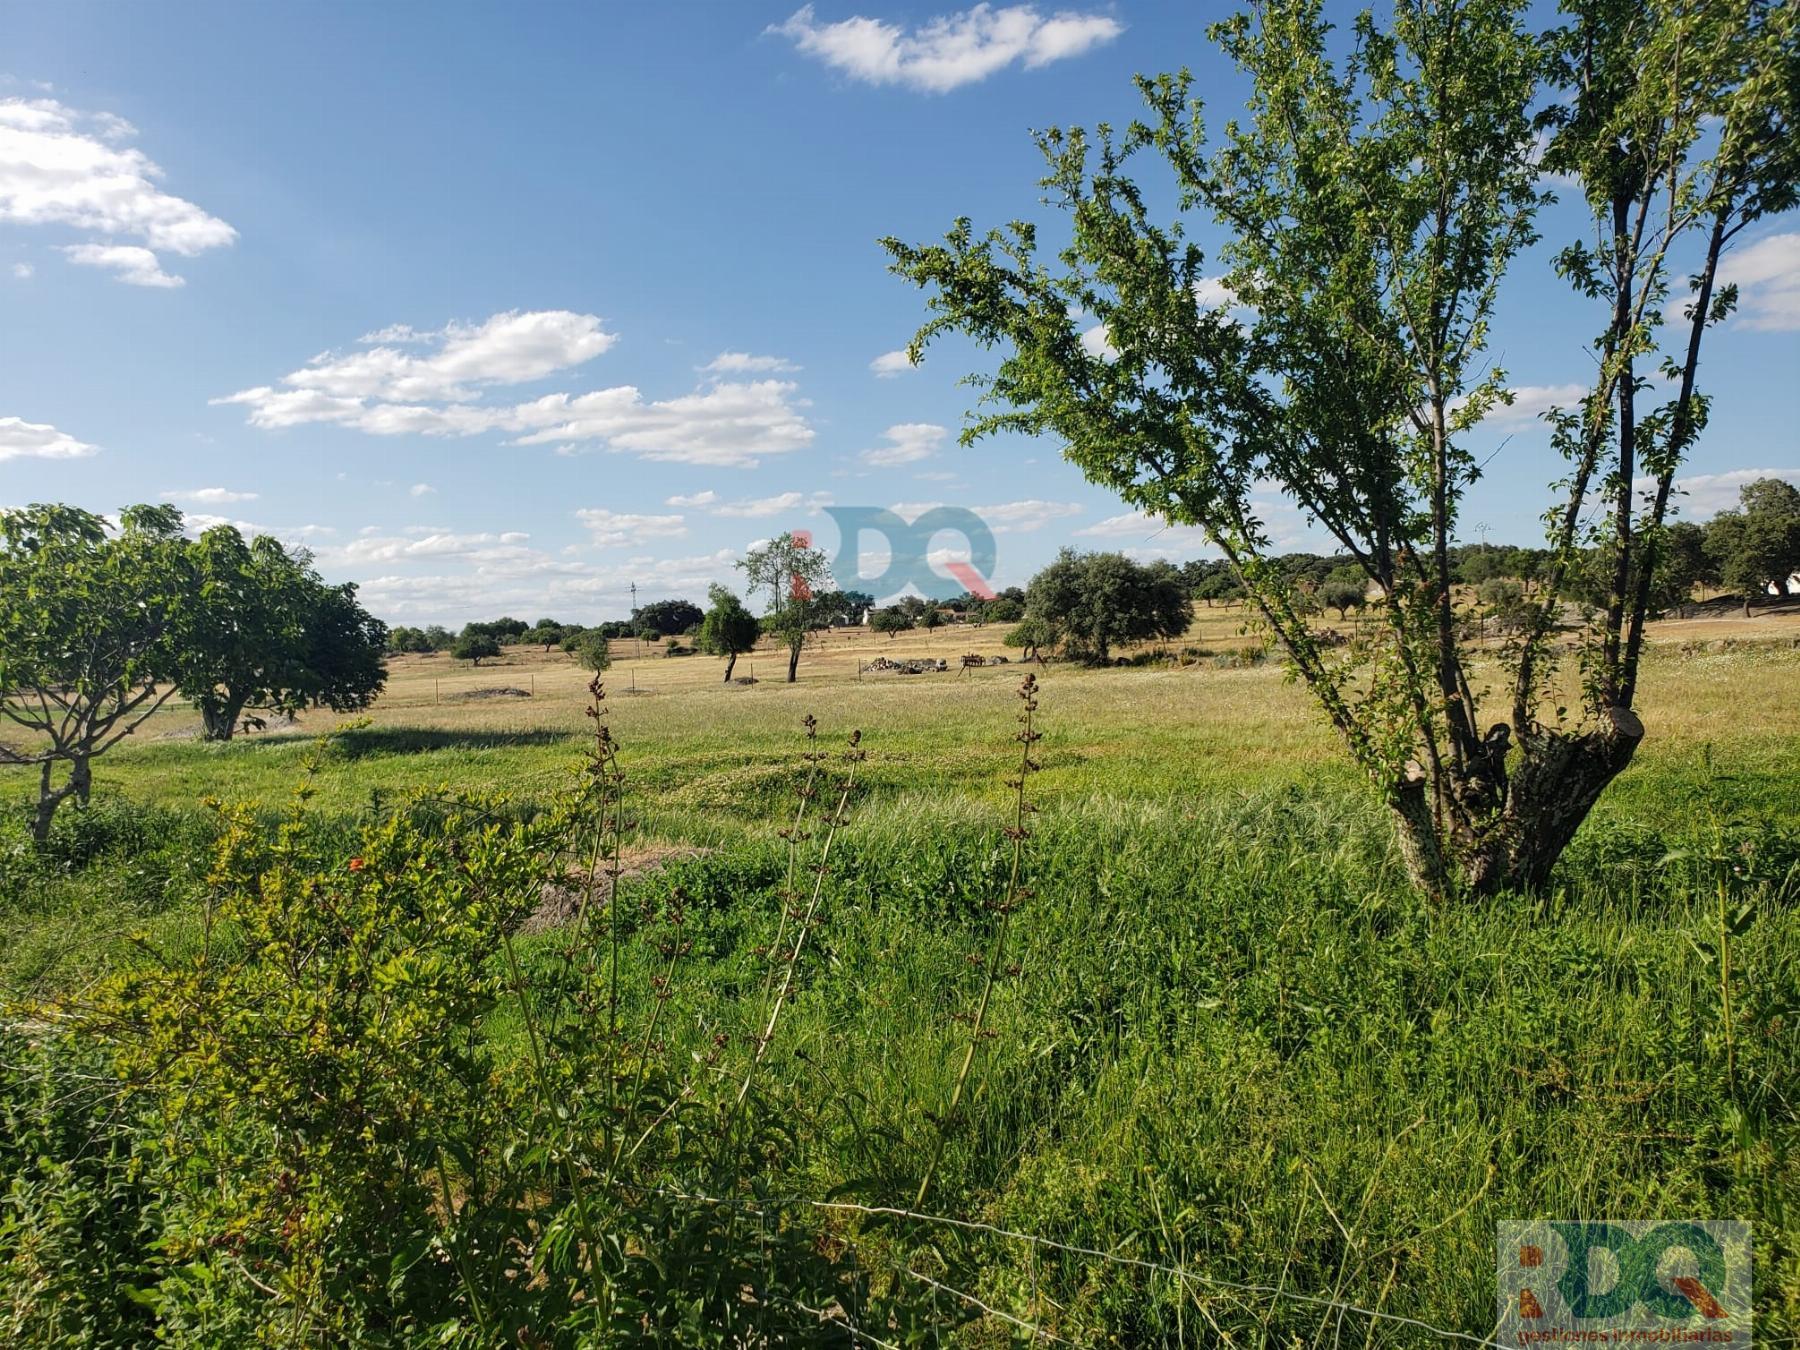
(0, 0, 1800, 623)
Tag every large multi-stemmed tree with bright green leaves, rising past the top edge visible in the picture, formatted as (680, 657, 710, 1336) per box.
(886, 0, 1795, 910)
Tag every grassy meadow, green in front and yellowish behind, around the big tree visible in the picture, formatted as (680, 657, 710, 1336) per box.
(0, 610, 1800, 1346)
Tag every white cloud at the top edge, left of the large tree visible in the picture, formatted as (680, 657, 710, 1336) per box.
(769, 4, 1125, 94)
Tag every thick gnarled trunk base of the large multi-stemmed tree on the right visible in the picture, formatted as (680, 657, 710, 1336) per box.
(1388, 707, 1643, 898)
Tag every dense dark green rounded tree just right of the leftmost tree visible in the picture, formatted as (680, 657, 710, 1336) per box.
(175, 526, 387, 740)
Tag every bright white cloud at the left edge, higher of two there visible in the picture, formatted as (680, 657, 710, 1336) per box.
(0, 97, 238, 286)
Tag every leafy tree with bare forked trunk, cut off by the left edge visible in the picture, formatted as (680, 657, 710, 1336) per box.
(0, 506, 193, 841)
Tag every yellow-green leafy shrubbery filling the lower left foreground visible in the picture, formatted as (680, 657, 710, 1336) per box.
(0, 712, 914, 1346)
